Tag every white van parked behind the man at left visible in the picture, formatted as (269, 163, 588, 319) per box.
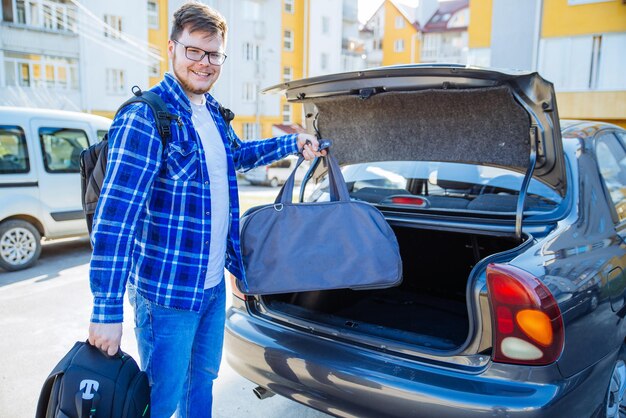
(0, 106, 111, 271)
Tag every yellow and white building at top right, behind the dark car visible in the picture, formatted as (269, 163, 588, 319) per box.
(468, 0, 626, 126)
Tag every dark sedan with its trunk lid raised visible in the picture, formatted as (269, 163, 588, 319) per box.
(226, 66, 626, 418)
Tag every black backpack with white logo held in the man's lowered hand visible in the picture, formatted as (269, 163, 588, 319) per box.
(35, 341, 150, 418)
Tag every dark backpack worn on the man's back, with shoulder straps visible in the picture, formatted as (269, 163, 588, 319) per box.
(80, 86, 234, 235)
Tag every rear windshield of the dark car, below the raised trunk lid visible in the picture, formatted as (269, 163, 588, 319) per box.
(305, 161, 562, 212)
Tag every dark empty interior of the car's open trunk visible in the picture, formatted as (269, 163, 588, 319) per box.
(262, 226, 517, 351)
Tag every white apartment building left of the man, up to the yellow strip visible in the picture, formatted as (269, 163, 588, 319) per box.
(0, 0, 157, 116)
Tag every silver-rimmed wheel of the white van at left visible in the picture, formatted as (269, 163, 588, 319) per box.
(0, 220, 41, 271)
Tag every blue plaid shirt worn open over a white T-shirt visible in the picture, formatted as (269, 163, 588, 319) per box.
(90, 74, 298, 322)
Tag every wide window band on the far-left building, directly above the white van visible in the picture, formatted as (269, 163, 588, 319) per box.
(4, 52, 78, 90)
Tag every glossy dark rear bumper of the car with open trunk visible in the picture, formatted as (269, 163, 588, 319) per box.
(225, 308, 613, 418)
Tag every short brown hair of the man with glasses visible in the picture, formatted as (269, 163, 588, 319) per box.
(170, 1, 228, 42)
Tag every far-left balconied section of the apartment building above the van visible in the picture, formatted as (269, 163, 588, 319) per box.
(0, 0, 83, 110)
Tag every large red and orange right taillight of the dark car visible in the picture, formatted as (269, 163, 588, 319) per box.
(487, 264, 564, 365)
